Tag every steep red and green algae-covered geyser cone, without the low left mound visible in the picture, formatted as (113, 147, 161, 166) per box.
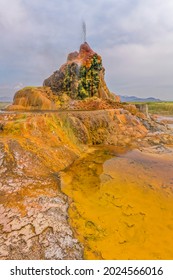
(44, 42, 118, 101)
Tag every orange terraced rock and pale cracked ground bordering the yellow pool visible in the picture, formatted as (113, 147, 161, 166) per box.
(0, 109, 173, 259)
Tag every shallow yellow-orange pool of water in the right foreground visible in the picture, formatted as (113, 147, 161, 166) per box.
(62, 148, 173, 259)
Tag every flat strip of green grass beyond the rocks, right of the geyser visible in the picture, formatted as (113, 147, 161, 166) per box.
(129, 101, 173, 116)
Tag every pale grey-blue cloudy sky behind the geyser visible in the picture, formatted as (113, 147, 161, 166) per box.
(0, 0, 173, 100)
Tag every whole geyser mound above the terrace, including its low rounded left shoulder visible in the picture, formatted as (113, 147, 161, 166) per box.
(8, 42, 120, 110)
